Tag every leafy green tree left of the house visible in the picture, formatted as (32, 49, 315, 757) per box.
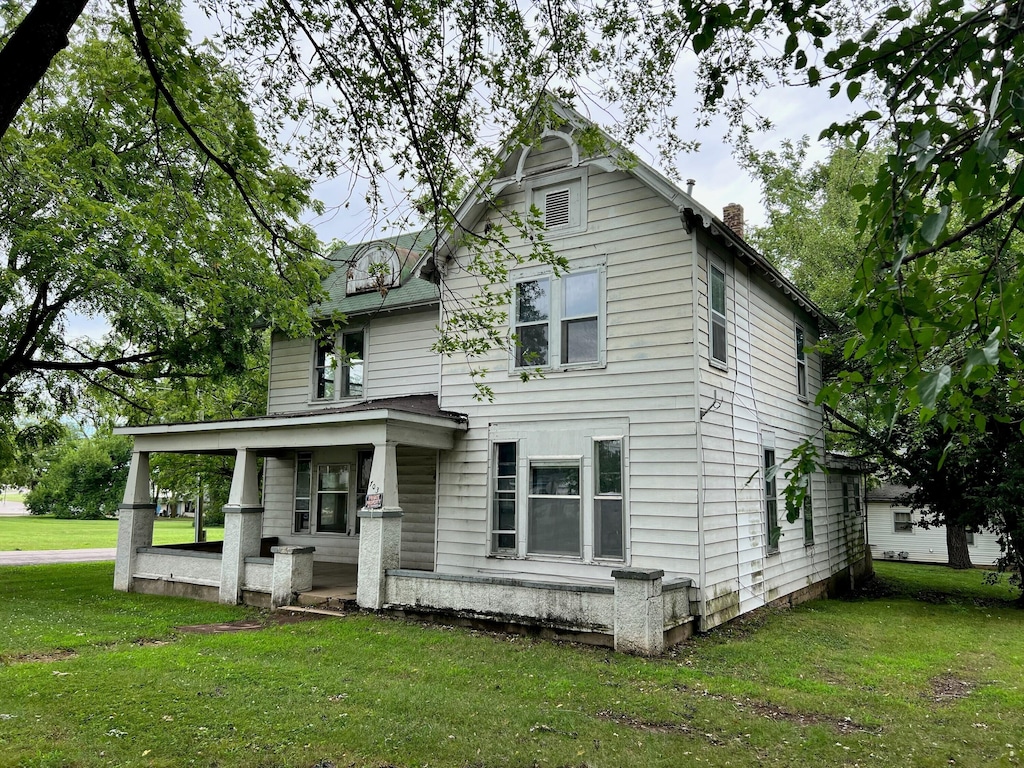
(0, 4, 324, 438)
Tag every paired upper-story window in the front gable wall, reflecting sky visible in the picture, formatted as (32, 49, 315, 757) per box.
(514, 269, 604, 369)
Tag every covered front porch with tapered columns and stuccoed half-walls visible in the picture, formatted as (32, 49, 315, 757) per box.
(114, 397, 465, 608)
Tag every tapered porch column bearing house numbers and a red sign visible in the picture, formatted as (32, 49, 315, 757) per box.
(355, 442, 402, 610)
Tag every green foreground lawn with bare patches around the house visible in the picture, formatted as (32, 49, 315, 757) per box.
(0, 563, 1024, 768)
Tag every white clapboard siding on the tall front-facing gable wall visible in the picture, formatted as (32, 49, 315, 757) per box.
(437, 159, 698, 579)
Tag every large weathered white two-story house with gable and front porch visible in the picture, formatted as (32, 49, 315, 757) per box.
(115, 102, 870, 652)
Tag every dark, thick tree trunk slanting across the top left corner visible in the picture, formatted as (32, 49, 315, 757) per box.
(0, 0, 89, 137)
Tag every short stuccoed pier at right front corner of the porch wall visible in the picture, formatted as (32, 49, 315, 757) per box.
(611, 568, 665, 656)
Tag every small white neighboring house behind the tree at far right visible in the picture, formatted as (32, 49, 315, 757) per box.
(867, 485, 999, 565)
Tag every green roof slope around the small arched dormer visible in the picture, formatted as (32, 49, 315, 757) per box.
(315, 229, 440, 316)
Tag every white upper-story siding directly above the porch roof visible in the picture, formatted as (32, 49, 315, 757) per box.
(267, 306, 439, 414)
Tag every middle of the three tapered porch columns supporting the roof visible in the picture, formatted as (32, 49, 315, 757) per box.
(219, 449, 263, 605)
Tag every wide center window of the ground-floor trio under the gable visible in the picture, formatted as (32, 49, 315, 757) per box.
(526, 460, 583, 557)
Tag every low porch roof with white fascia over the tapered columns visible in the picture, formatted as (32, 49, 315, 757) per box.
(115, 395, 467, 455)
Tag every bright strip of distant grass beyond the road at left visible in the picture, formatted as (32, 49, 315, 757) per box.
(0, 515, 224, 552)
